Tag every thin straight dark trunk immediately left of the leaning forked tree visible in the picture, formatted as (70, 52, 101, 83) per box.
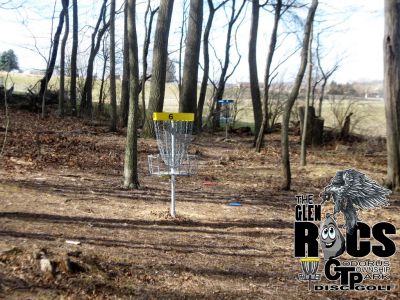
(69, 0, 78, 116)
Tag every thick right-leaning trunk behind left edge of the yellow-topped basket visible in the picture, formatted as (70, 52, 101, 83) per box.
(143, 0, 174, 137)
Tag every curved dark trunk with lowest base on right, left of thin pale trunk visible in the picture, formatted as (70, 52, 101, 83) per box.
(281, 0, 318, 190)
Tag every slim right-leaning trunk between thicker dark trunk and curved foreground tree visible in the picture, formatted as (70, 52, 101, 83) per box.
(256, 0, 282, 152)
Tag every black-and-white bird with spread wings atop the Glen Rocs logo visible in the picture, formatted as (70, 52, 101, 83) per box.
(320, 169, 391, 234)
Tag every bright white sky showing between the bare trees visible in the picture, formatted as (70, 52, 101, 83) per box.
(0, 0, 383, 82)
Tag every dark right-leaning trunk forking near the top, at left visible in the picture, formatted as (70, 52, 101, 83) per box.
(81, 0, 110, 115)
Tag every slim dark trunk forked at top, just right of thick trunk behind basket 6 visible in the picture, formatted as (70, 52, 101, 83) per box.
(196, 0, 228, 131)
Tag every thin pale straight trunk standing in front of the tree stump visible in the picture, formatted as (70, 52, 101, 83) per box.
(300, 26, 313, 167)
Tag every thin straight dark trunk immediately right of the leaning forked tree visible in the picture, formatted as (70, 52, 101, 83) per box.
(110, 0, 117, 131)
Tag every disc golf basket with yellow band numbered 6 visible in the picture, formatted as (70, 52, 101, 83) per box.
(148, 112, 198, 217)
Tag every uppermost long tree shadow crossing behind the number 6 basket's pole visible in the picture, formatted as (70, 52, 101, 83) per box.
(1, 179, 294, 208)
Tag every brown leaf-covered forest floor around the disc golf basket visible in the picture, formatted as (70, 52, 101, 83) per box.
(0, 111, 400, 299)
